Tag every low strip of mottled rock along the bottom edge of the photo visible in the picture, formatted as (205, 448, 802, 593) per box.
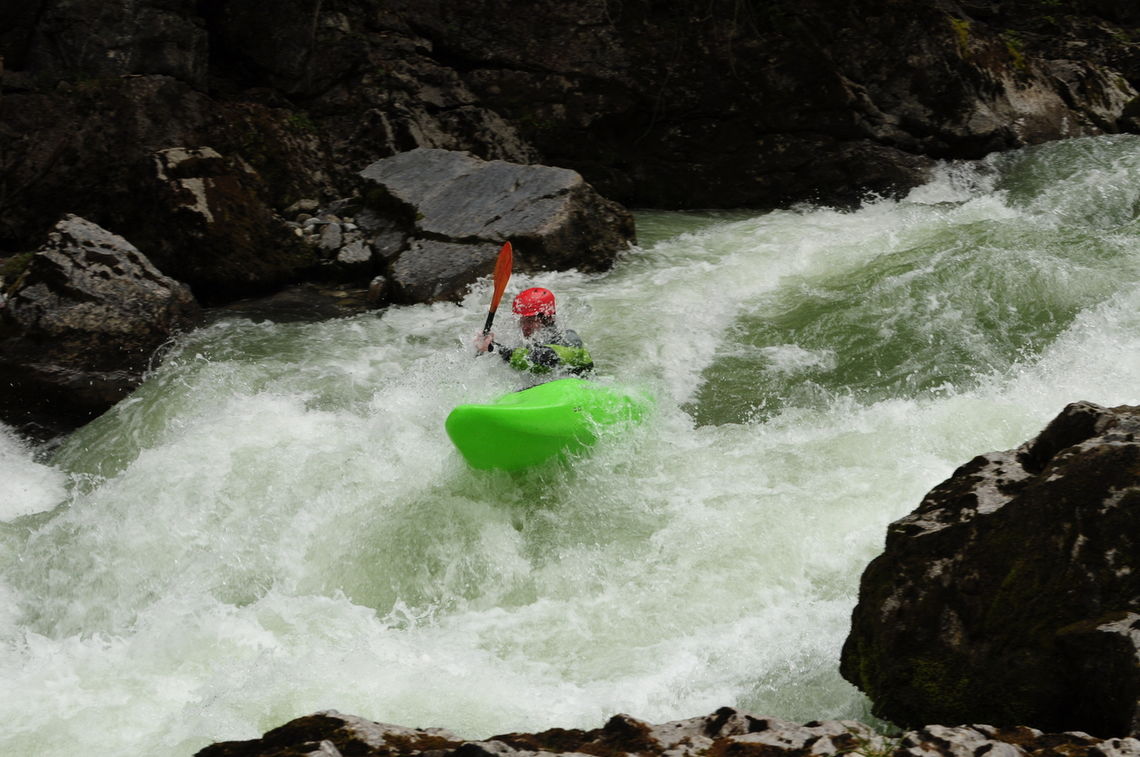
(196, 707, 1140, 757)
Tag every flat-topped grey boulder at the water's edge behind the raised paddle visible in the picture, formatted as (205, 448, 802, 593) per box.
(360, 148, 635, 302)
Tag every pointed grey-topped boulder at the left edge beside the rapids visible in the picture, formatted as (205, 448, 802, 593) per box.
(0, 215, 201, 432)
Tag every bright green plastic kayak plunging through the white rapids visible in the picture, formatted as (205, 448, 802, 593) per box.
(445, 379, 645, 471)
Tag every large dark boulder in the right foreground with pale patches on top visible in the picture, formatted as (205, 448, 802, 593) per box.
(841, 402, 1140, 736)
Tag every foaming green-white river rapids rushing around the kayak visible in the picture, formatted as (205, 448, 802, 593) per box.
(0, 137, 1140, 757)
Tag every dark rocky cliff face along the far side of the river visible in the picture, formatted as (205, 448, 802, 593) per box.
(0, 0, 1140, 257)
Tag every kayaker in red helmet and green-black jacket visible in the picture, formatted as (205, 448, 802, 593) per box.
(475, 286, 594, 375)
